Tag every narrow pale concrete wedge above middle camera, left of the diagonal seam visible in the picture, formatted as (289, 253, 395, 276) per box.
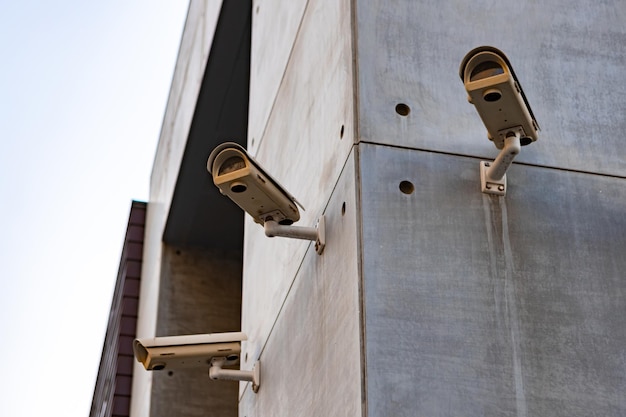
(248, 0, 308, 147)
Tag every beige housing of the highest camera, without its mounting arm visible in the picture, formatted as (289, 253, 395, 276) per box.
(459, 46, 539, 149)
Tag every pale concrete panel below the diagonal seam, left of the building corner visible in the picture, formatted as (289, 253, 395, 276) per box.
(239, 150, 363, 417)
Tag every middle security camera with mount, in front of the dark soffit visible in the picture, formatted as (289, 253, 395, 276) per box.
(207, 142, 325, 254)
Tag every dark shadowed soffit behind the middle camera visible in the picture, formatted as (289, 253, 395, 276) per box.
(163, 0, 252, 250)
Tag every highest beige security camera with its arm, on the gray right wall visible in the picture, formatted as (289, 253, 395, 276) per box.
(459, 46, 539, 195)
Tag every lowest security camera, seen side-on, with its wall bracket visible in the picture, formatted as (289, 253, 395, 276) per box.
(133, 333, 260, 392)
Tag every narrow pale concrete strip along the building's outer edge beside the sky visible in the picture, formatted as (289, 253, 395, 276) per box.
(131, 0, 222, 417)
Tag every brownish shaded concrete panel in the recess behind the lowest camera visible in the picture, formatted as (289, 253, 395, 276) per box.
(149, 246, 241, 417)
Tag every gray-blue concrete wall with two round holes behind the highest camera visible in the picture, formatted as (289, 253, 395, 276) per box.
(355, 0, 626, 417)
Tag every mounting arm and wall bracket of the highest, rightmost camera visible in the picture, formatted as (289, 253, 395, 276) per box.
(480, 126, 524, 195)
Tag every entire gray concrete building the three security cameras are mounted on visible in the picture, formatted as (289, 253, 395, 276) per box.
(91, 0, 626, 417)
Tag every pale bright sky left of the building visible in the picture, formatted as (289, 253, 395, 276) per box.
(0, 0, 188, 417)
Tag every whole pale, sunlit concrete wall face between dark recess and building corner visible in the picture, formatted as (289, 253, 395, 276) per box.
(240, 0, 363, 416)
